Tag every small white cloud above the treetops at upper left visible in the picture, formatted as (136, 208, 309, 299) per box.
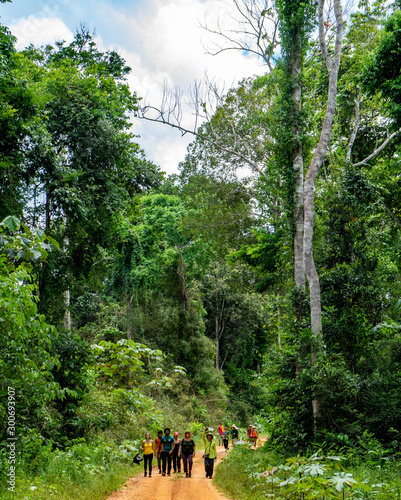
(10, 15, 74, 49)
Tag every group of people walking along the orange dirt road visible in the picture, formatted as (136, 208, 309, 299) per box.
(141, 424, 247, 479)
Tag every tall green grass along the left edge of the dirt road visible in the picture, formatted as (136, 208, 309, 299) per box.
(0, 422, 203, 500)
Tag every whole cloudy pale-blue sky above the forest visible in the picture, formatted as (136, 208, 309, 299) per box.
(0, 0, 265, 174)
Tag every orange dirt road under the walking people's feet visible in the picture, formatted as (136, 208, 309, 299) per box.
(107, 446, 228, 500)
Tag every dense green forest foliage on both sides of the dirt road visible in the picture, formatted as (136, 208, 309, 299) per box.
(0, 0, 401, 498)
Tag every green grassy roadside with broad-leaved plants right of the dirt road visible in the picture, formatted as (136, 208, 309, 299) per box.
(215, 445, 401, 500)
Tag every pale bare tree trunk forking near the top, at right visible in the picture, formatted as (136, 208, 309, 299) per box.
(304, 0, 343, 430)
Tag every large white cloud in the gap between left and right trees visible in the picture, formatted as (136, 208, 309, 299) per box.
(93, 0, 264, 172)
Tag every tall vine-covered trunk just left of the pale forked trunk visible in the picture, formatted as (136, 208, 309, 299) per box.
(275, 0, 315, 291)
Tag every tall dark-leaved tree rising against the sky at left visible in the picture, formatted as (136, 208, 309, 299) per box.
(8, 27, 161, 321)
